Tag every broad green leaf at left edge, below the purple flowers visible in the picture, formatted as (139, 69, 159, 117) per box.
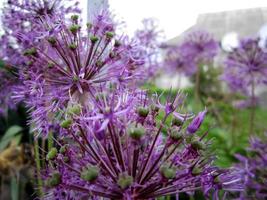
(0, 125, 22, 151)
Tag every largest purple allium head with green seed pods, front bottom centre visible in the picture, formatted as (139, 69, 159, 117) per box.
(44, 88, 245, 200)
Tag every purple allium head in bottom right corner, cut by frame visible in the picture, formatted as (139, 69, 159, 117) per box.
(236, 134, 267, 200)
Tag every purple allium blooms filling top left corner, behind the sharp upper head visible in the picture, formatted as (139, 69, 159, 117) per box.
(0, 0, 80, 113)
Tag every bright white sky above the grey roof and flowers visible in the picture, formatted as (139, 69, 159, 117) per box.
(105, 0, 267, 39)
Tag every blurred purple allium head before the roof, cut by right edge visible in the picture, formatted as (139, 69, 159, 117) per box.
(222, 38, 267, 97)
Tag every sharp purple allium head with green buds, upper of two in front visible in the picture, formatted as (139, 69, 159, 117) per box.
(15, 11, 144, 133)
